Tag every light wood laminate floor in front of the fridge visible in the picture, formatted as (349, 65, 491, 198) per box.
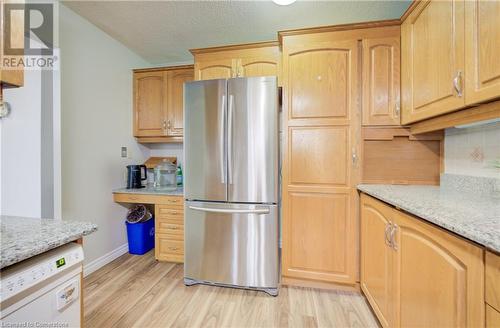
(83, 252, 378, 327)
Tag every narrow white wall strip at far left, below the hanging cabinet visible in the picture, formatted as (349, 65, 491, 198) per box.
(0, 71, 42, 217)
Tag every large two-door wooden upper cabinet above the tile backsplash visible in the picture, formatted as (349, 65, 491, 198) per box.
(401, 0, 500, 124)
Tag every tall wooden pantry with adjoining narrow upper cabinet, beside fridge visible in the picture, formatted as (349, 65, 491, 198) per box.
(280, 21, 406, 286)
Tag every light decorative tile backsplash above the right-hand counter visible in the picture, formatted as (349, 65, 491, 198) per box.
(444, 122, 500, 178)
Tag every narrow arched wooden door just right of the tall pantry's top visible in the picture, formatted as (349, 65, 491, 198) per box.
(363, 32, 400, 125)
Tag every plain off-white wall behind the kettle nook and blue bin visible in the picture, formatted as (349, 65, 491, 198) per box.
(59, 5, 149, 270)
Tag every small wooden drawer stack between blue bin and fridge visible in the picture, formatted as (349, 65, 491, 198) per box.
(155, 201, 184, 263)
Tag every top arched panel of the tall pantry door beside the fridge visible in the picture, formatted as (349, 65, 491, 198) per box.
(288, 43, 356, 119)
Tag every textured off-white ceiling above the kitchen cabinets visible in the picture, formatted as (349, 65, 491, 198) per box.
(64, 0, 411, 64)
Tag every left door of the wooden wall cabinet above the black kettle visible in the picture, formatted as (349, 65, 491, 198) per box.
(134, 71, 166, 137)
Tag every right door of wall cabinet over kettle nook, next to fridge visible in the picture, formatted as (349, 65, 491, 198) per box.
(166, 69, 193, 136)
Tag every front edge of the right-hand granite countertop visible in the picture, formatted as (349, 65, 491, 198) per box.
(357, 186, 500, 254)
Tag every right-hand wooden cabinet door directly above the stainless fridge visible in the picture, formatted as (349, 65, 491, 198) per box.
(238, 46, 279, 77)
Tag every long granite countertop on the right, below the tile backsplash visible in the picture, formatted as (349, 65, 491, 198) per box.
(358, 178, 500, 253)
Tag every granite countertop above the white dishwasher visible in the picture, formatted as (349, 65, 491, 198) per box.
(0, 215, 97, 269)
